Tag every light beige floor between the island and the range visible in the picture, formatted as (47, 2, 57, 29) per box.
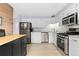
(27, 43, 62, 56)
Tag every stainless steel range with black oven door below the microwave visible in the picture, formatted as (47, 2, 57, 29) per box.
(57, 33, 69, 55)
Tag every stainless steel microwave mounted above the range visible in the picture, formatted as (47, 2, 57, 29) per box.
(62, 12, 78, 25)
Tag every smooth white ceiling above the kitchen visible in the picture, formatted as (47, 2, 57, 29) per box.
(9, 3, 67, 17)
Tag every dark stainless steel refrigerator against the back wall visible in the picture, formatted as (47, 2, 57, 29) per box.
(19, 22, 32, 44)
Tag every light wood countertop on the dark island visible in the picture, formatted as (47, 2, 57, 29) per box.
(0, 35, 25, 46)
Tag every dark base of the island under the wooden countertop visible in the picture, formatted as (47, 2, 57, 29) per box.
(0, 37, 27, 56)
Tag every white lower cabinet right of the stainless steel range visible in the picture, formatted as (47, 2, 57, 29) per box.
(69, 37, 79, 56)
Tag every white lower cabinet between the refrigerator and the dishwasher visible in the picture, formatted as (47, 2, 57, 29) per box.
(31, 32, 41, 43)
